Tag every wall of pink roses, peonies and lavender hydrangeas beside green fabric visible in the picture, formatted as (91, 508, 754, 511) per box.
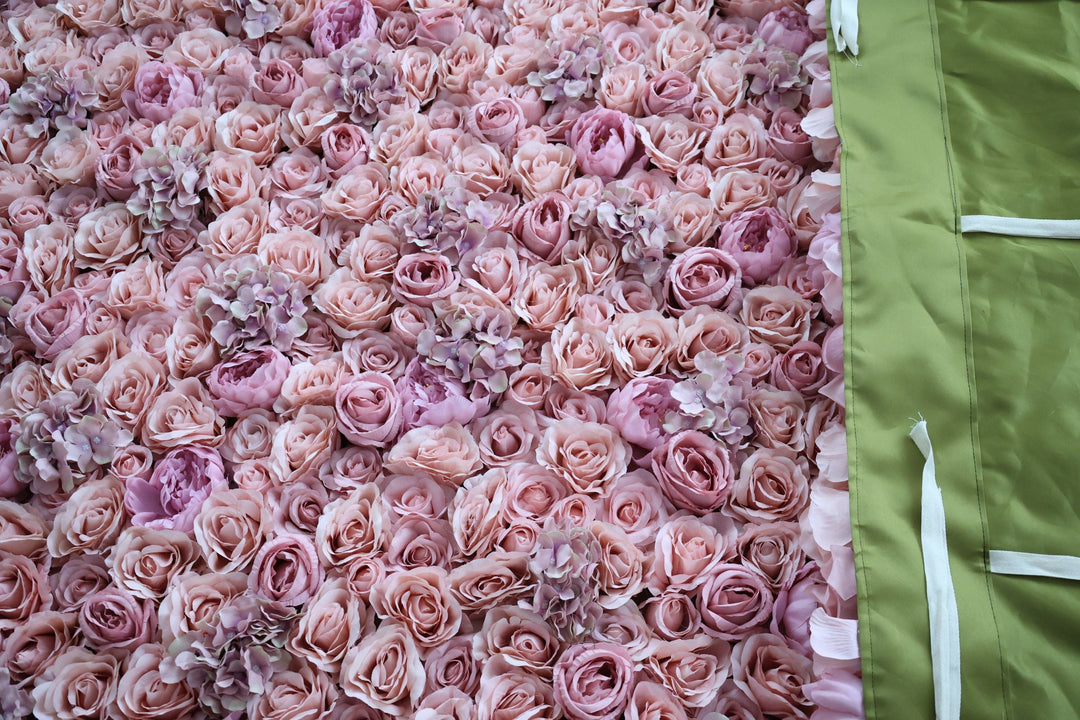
(0, 0, 861, 720)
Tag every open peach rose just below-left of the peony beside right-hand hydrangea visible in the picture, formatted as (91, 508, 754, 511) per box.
(537, 418, 630, 497)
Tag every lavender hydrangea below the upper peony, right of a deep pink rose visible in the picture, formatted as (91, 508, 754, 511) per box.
(587, 185, 672, 285)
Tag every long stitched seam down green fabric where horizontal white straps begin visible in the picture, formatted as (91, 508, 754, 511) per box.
(927, 0, 1013, 719)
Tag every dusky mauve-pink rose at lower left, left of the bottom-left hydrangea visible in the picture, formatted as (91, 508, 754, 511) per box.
(79, 587, 158, 652)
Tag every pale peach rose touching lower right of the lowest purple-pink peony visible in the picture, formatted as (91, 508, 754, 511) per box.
(194, 486, 270, 573)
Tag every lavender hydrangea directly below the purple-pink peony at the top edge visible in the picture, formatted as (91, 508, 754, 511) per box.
(323, 40, 402, 130)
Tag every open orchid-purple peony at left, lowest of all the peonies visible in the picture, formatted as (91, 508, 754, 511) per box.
(124, 445, 226, 533)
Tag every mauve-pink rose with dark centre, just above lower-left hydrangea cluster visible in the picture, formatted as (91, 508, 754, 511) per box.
(247, 533, 324, 606)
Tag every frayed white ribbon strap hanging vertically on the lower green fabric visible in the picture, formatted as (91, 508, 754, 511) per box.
(910, 420, 960, 720)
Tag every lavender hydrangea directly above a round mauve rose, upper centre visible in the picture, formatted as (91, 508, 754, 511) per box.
(390, 188, 487, 261)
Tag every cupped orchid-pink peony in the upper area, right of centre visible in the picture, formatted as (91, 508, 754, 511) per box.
(570, 107, 646, 181)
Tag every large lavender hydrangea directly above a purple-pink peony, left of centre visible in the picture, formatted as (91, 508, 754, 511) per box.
(195, 255, 308, 355)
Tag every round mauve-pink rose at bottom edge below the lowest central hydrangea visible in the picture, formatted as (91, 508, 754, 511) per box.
(554, 642, 634, 720)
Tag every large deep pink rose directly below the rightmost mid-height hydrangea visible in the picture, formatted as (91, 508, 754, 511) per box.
(650, 430, 734, 515)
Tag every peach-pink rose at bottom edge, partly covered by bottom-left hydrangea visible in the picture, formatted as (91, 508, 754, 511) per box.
(116, 643, 198, 720)
